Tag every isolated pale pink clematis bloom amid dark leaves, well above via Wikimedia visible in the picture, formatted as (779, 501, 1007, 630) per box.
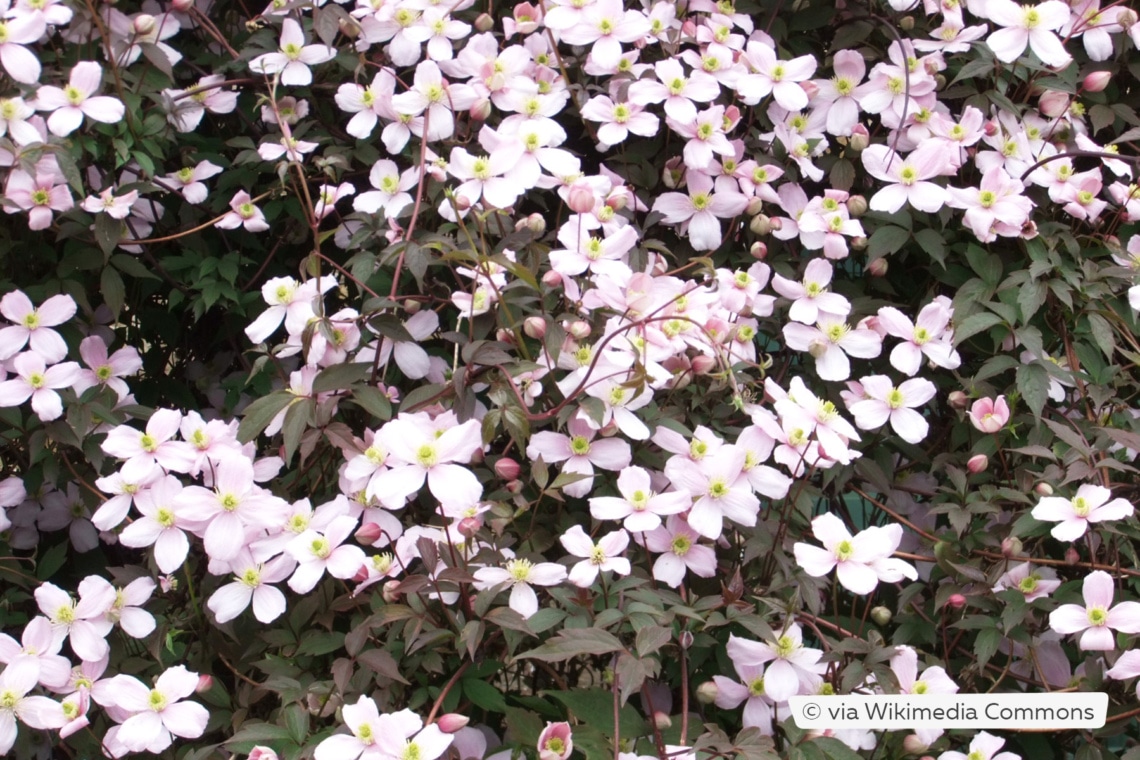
(792, 513, 918, 596)
